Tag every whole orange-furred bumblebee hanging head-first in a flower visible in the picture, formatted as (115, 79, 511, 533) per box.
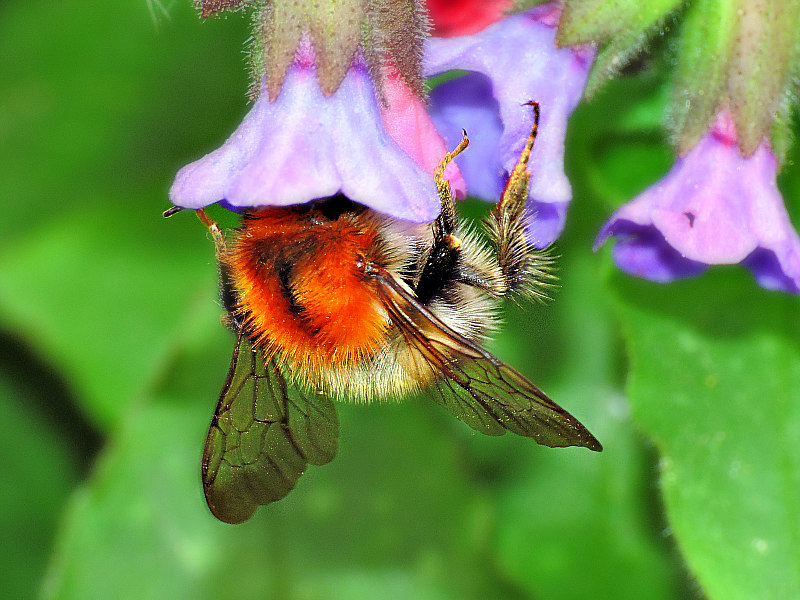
(181, 103, 602, 523)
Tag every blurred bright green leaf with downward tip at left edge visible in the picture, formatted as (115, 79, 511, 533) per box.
(0, 206, 215, 426)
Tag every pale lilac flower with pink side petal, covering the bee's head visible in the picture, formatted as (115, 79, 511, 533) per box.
(170, 36, 464, 223)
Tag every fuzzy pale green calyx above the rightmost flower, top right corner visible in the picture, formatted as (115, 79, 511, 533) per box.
(668, 0, 800, 160)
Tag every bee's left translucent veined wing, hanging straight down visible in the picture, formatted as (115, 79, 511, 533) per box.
(202, 330, 339, 523)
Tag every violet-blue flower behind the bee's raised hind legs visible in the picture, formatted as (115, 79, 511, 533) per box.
(425, 3, 594, 247)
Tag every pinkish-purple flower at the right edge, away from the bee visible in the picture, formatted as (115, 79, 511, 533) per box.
(595, 111, 800, 293)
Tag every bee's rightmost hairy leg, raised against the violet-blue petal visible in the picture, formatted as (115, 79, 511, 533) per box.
(486, 101, 555, 300)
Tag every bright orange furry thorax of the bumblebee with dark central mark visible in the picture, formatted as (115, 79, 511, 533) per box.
(228, 207, 389, 372)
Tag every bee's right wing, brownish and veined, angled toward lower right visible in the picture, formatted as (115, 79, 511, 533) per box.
(371, 269, 603, 451)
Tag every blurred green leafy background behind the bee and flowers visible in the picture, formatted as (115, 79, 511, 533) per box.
(0, 0, 800, 600)
